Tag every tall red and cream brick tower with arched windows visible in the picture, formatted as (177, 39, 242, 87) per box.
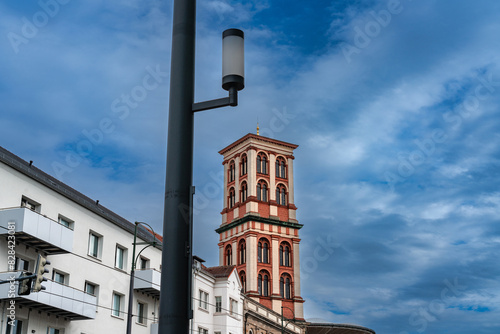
(216, 134, 304, 320)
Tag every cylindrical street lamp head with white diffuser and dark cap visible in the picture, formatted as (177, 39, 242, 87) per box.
(222, 29, 245, 90)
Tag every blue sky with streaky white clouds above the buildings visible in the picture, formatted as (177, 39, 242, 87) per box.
(0, 0, 500, 334)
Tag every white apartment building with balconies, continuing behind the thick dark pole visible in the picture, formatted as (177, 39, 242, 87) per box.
(0, 147, 243, 334)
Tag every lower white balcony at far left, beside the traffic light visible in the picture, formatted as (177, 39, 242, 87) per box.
(0, 272, 97, 320)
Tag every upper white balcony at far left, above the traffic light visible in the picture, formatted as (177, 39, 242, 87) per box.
(0, 208, 73, 254)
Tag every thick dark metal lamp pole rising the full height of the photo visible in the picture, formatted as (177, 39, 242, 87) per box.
(159, 0, 196, 334)
